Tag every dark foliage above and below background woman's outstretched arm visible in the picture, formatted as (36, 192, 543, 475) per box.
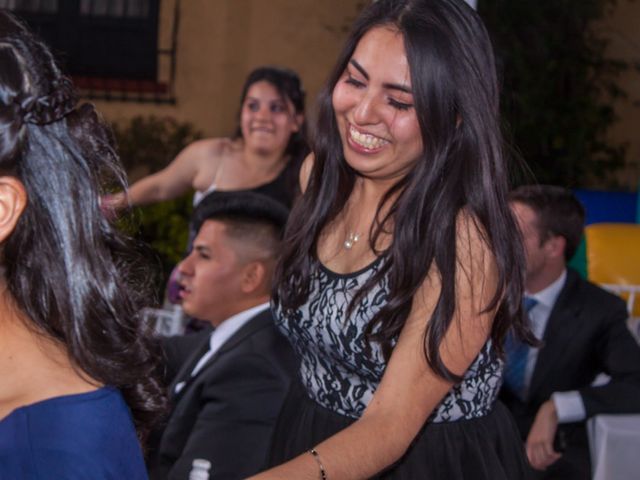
(113, 116, 201, 286)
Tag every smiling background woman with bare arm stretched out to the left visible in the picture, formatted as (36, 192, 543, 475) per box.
(104, 66, 308, 213)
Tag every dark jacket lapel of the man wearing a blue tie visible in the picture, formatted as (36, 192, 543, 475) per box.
(529, 269, 580, 398)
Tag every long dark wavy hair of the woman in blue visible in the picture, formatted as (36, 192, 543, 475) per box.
(0, 12, 165, 439)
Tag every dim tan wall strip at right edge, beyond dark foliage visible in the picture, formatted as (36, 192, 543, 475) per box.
(604, 0, 640, 190)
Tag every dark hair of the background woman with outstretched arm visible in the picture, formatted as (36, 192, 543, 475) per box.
(234, 66, 309, 199)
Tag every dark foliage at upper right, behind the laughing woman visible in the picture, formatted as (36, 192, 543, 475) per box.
(478, 0, 628, 187)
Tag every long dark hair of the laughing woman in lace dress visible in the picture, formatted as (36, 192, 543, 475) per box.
(275, 0, 533, 381)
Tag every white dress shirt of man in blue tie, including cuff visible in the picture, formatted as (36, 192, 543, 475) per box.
(524, 270, 587, 423)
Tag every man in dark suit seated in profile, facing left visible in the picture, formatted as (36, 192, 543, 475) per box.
(149, 192, 296, 480)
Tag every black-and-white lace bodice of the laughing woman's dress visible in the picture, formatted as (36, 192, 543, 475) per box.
(274, 259, 502, 423)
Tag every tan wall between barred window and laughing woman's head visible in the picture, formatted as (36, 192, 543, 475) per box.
(96, 0, 364, 136)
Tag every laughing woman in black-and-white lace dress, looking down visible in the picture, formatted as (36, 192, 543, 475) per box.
(255, 0, 532, 480)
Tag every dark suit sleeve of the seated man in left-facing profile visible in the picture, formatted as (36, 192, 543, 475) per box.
(168, 354, 288, 480)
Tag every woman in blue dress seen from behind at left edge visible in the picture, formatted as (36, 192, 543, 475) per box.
(0, 12, 164, 480)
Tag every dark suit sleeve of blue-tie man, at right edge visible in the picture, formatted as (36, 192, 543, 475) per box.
(579, 292, 640, 417)
